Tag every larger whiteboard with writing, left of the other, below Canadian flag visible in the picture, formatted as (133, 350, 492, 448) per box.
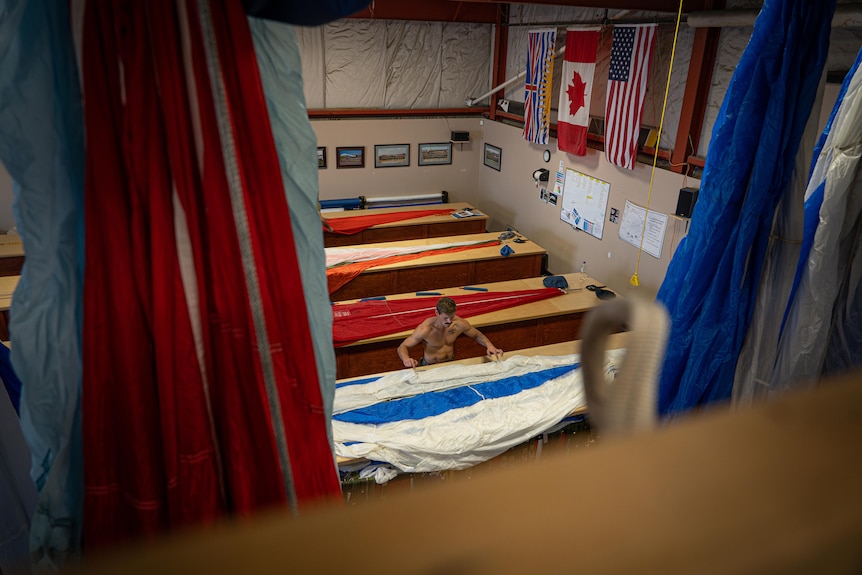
(560, 168, 611, 239)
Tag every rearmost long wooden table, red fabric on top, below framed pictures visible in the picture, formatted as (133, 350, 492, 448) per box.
(323, 202, 488, 247)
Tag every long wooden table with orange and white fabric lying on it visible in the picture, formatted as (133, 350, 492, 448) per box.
(329, 232, 547, 301)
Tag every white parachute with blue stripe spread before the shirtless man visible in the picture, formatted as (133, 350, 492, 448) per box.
(332, 350, 625, 472)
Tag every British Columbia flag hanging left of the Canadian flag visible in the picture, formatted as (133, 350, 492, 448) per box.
(524, 28, 557, 144)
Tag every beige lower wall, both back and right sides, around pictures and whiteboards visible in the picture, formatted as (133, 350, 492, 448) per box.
(312, 114, 700, 298)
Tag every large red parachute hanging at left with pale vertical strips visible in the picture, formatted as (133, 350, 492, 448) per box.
(82, 0, 340, 550)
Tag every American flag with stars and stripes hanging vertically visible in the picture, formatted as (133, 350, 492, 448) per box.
(605, 24, 657, 170)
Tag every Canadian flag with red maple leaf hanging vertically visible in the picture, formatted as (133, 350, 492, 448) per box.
(557, 28, 600, 156)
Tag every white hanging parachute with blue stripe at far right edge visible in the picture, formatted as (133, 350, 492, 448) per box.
(770, 52, 862, 394)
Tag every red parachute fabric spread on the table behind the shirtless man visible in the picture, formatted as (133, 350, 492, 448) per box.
(332, 288, 565, 347)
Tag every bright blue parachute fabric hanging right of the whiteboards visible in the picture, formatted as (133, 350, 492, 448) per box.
(657, 0, 835, 416)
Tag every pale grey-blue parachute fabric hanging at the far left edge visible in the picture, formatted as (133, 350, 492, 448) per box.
(0, 0, 84, 571)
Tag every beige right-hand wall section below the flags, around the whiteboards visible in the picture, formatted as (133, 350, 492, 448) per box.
(476, 122, 700, 299)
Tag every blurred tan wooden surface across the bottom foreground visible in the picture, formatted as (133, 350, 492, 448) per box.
(74, 371, 862, 575)
